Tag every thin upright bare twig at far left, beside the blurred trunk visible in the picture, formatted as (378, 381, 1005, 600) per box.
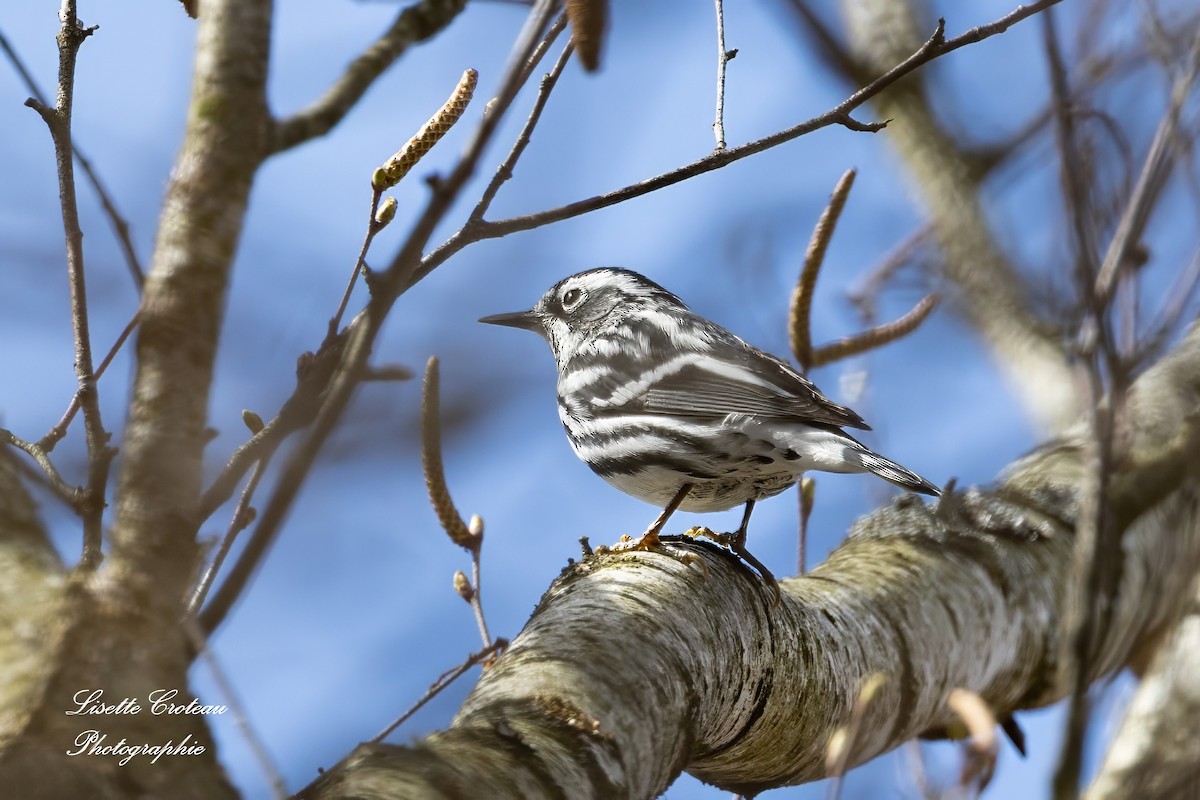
(25, 0, 115, 570)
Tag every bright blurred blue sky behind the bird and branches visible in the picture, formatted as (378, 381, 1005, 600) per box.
(0, 0, 1185, 800)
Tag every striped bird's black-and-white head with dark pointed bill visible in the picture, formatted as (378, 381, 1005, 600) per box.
(479, 266, 686, 363)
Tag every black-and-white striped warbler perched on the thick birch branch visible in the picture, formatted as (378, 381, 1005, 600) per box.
(479, 266, 940, 602)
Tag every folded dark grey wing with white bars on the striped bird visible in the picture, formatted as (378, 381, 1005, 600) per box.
(624, 345, 870, 429)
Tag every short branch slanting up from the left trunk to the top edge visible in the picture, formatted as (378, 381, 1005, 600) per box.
(270, 0, 467, 154)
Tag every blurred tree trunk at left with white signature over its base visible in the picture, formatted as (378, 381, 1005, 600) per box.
(0, 0, 271, 800)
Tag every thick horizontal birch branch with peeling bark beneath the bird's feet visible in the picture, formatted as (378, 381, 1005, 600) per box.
(301, 325, 1200, 800)
